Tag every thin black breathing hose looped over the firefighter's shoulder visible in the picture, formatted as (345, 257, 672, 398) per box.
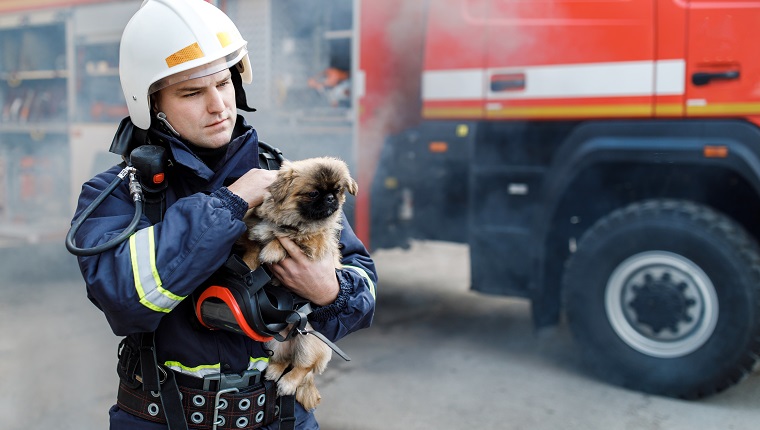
(66, 166, 143, 256)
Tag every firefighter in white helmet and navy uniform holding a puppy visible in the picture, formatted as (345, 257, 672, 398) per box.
(74, 0, 377, 429)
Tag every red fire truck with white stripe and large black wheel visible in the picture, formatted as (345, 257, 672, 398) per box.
(356, 0, 760, 398)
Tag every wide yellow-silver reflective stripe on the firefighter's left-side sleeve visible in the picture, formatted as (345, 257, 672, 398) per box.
(129, 226, 184, 312)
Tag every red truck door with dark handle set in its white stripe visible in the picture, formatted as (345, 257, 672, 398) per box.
(486, 0, 656, 119)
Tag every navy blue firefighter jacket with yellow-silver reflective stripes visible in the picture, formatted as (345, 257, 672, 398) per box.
(74, 116, 377, 428)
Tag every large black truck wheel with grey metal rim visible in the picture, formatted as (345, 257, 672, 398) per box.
(563, 200, 760, 399)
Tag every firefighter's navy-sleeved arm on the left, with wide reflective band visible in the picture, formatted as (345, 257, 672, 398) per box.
(76, 170, 247, 335)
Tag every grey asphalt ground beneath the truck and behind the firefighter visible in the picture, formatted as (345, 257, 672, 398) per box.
(0, 242, 760, 430)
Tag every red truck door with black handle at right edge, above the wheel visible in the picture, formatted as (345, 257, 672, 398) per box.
(685, 0, 760, 121)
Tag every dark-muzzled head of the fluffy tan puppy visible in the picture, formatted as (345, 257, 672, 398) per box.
(269, 157, 358, 224)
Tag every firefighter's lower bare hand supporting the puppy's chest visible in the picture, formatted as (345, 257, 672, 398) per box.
(270, 237, 340, 306)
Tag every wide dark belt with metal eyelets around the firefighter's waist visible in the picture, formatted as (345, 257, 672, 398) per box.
(117, 375, 279, 430)
